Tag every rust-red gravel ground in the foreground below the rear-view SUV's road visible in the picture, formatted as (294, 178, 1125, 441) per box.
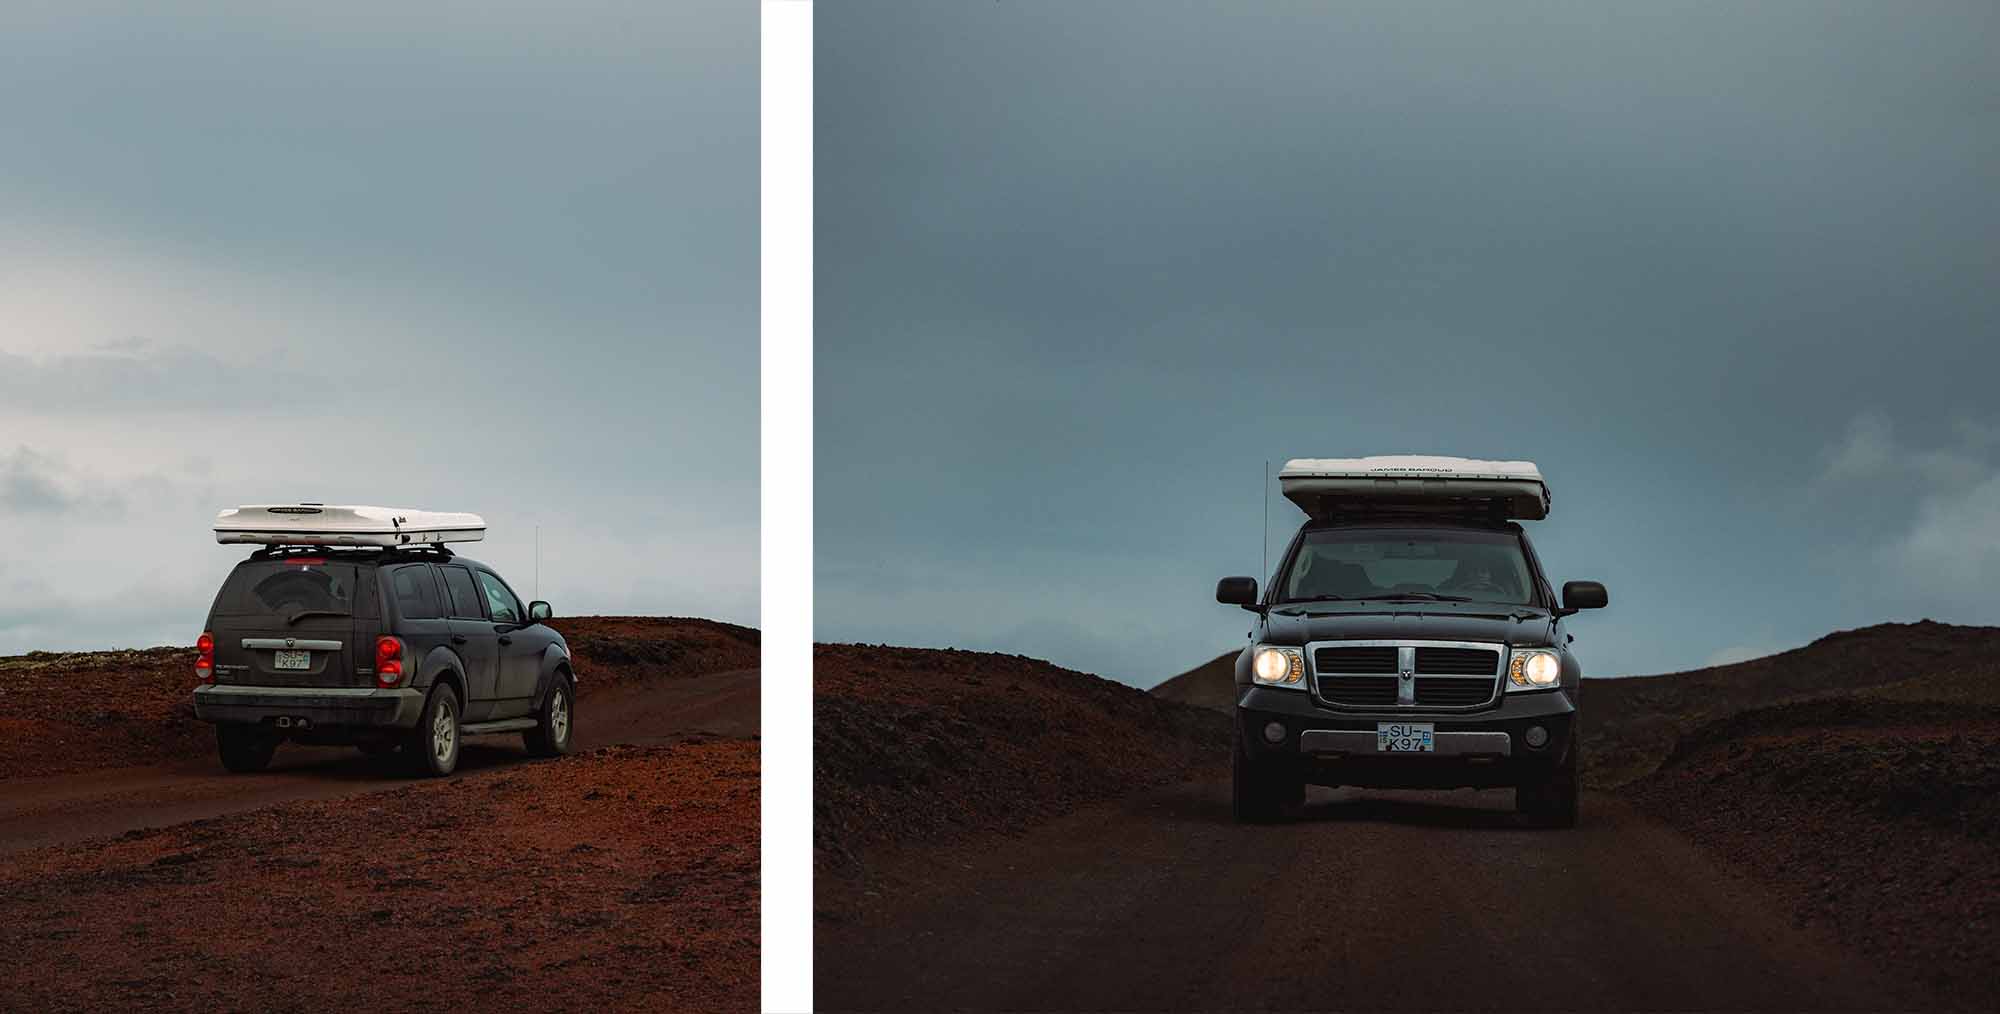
(0, 740, 758, 1010)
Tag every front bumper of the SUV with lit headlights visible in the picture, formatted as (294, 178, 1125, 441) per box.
(1236, 686, 1576, 788)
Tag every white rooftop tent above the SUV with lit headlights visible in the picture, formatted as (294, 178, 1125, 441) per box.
(1278, 454, 1548, 520)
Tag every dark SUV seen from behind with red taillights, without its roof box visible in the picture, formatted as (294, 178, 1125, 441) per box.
(194, 546, 576, 776)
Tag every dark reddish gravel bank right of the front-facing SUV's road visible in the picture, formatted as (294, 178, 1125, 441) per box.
(1624, 700, 2000, 1010)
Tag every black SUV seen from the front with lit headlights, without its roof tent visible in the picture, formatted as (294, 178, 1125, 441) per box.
(1216, 512, 1606, 826)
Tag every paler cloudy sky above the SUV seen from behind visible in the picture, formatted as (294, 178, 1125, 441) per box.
(0, 0, 758, 654)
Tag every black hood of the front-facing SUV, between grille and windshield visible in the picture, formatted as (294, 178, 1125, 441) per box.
(1264, 602, 1554, 646)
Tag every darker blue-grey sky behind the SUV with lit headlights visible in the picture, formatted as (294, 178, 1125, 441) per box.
(814, 0, 2000, 686)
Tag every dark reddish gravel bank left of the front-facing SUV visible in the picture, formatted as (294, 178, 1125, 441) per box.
(812, 644, 1230, 874)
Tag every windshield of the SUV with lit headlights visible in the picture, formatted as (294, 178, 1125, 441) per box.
(1278, 528, 1534, 606)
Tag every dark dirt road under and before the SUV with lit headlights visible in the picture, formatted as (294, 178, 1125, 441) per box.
(816, 782, 1900, 1010)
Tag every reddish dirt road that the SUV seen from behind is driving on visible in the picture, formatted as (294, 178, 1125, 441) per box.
(0, 668, 758, 854)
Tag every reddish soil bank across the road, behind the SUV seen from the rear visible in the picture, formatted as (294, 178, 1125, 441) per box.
(0, 616, 758, 780)
